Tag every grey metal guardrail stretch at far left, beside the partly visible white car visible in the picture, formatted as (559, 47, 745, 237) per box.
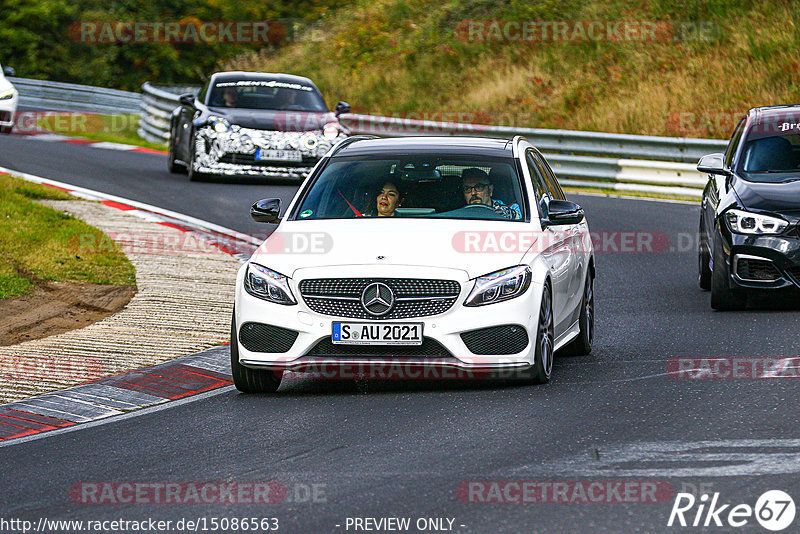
(8, 76, 141, 115)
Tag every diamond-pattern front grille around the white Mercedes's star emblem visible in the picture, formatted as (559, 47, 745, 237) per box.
(299, 278, 461, 320)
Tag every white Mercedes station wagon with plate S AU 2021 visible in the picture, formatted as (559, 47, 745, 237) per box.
(231, 136, 595, 393)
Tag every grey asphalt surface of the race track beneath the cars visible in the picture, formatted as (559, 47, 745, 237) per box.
(0, 136, 800, 533)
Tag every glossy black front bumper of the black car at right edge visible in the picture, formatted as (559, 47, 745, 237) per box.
(723, 227, 800, 289)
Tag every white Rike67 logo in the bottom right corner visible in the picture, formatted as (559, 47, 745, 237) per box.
(667, 490, 795, 532)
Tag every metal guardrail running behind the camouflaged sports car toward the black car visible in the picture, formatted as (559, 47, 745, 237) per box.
(139, 83, 727, 198)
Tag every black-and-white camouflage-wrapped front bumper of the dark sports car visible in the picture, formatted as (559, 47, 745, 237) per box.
(194, 126, 346, 180)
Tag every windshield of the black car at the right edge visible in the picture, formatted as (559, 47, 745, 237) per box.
(741, 123, 800, 182)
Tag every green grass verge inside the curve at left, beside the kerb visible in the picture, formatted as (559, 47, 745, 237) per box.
(0, 174, 136, 299)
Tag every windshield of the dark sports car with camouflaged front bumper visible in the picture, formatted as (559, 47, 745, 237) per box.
(208, 80, 328, 111)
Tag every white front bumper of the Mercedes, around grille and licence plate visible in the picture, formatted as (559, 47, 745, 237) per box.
(235, 265, 542, 377)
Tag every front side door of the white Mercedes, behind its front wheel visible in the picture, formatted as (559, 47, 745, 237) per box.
(525, 148, 573, 338)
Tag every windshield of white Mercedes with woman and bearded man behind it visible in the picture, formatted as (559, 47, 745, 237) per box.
(295, 156, 526, 221)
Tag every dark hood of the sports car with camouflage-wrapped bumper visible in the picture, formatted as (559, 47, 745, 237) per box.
(208, 107, 339, 132)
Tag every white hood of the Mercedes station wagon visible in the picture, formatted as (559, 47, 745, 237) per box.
(251, 219, 537, 278)
